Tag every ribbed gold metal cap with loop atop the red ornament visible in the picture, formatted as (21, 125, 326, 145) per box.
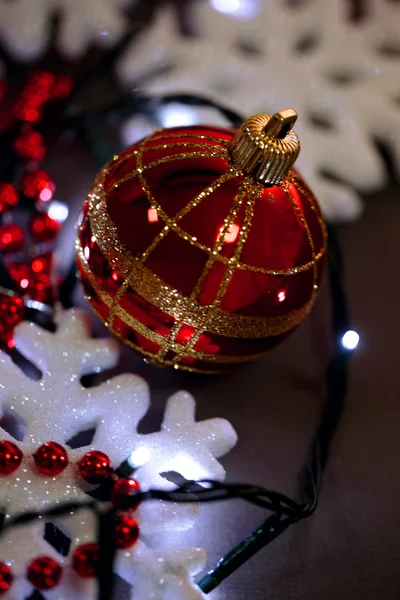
(229, 108, 300, 185)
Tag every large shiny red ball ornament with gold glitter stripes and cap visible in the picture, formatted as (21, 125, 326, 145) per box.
(78, 110, 326, 372)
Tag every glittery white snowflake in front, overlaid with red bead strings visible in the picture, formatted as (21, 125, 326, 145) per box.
(0, 310, 236, 600)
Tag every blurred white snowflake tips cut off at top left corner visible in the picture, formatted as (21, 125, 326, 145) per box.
(0, 0, 131, 60)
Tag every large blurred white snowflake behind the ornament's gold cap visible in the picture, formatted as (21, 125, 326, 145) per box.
(118, 0, 400, 220)
